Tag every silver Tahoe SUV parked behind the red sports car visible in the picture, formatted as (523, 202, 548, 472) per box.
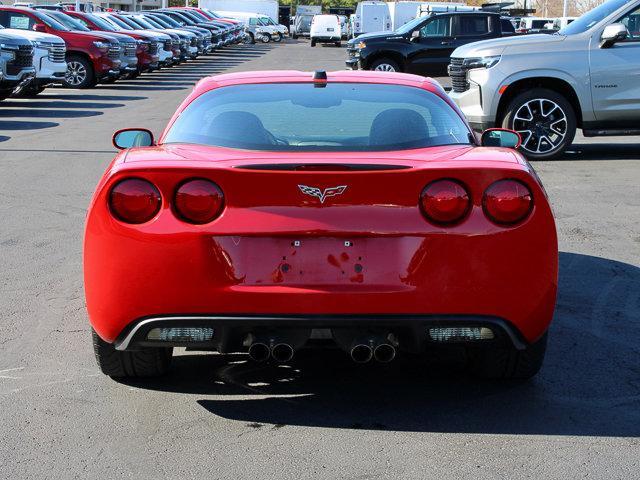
(449, 0, 640, 159)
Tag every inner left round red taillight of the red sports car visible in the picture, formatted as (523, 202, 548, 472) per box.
(174, 178, 224, 224)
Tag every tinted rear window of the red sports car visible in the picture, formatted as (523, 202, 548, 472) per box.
(164, 83, 470, 152)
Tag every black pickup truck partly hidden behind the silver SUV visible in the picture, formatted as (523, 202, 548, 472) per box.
(346, 11, 515, 76)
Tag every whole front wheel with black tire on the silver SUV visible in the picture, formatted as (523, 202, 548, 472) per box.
(502, 88, 577, 160)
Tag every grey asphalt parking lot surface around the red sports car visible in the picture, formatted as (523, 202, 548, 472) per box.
(0, 40, 640, 479)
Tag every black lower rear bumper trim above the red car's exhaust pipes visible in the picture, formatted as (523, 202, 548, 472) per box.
(114, 315, 527, 353)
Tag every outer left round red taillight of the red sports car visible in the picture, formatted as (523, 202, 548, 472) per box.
(109, 178, 162, 223)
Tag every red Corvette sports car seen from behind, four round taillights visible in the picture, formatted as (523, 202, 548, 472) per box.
(84, 71, 558, 378)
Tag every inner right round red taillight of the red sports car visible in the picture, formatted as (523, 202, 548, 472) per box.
(420, 180, 471, 224)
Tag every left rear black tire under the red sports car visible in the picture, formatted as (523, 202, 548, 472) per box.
(91, 329, 173, 378)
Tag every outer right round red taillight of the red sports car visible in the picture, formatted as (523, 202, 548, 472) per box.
(482, 180, 533, 225)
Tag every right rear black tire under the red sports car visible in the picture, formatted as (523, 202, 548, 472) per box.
(467, 332, 548, 380)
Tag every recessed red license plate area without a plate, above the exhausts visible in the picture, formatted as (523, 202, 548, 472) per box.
(214, 236, 426, 286)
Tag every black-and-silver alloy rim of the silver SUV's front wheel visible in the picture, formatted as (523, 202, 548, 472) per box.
(513, 98, 568, 154)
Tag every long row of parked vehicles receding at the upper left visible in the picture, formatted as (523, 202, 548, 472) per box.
(0, 5, 276, 100)
